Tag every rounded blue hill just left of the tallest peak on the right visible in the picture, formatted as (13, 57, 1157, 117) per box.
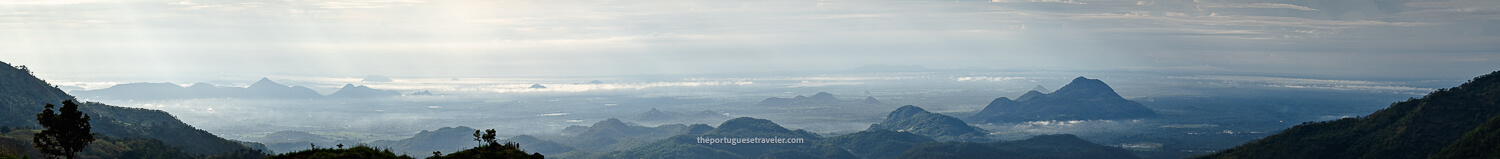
(870, 105, 987, 141)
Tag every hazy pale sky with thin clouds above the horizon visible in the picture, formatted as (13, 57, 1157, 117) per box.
(0, 0, 1500, 78)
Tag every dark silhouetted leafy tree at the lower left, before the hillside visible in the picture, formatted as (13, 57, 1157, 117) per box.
(32, 99, 95, 159)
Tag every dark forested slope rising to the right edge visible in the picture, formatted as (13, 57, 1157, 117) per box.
(1200, 71, 1500, 159)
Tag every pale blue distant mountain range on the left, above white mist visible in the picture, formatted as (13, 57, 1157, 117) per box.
(72, 78, 405, 101)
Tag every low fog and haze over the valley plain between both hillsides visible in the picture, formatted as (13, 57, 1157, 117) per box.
(54, 72, 1440, 147)
